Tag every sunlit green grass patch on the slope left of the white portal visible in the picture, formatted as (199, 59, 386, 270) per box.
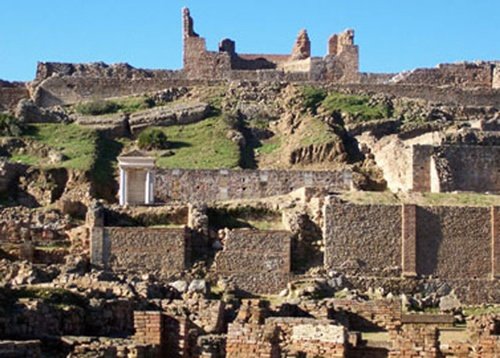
(11, 123, 98, 170)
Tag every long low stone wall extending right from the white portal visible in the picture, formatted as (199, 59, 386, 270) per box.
(155, 169, 352, 203)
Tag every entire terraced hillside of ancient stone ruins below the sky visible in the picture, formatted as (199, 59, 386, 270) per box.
(0, 4, 500, 358)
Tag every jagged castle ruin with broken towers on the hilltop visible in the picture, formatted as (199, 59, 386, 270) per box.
(182, 8, 359, 83)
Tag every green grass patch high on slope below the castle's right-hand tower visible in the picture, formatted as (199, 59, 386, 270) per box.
(321, 92, 391, 121)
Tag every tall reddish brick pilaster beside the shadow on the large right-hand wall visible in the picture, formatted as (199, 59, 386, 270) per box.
(401, 205, 417, 277)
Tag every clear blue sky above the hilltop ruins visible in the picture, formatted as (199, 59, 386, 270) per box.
(0, 0, 500, 80)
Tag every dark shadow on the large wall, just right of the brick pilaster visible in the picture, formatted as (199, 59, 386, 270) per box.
(417, 207, 444, 275)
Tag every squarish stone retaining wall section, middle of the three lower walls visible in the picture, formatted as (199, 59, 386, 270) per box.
(215, 230, 291, 294)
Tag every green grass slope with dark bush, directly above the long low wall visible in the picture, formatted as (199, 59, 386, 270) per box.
(157, 116, 240, 169)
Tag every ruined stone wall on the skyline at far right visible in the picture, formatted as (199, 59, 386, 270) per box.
(395, 62, 494, 88)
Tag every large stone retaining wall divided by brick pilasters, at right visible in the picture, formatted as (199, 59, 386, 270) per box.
(324, 200, 500, 279)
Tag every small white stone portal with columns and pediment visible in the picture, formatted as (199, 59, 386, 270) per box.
(118, 150, 155, 205)
